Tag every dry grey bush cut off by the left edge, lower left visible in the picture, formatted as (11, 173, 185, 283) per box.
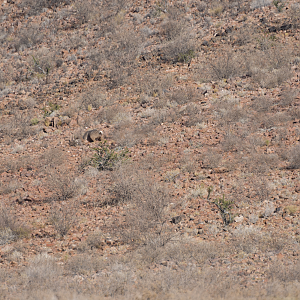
(0, 206, 29, 245)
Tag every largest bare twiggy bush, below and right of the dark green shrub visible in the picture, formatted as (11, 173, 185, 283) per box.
(111, 164, 170, 248)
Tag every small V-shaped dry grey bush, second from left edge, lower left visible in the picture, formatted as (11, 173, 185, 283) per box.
(49, 201, 78, 236)
